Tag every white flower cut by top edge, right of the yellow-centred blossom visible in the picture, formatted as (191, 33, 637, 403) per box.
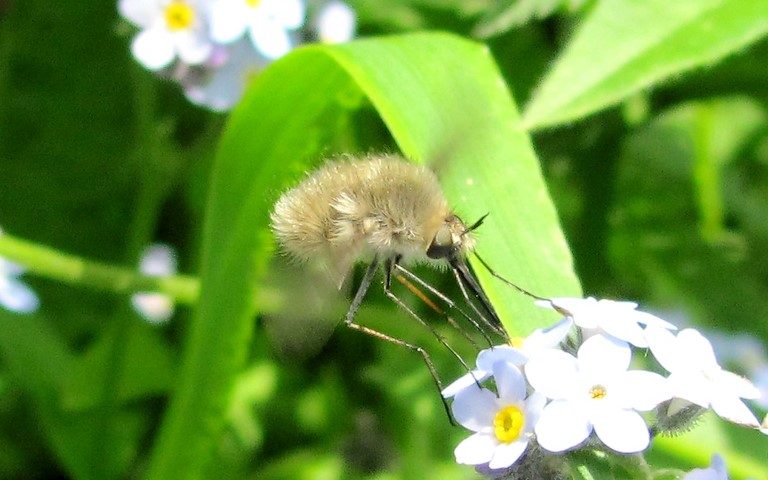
(211, 0, 305, 59)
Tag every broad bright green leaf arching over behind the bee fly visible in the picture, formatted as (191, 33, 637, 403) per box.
(142, 34, 580, 479)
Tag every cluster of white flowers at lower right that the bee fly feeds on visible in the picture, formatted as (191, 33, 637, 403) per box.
(443, 298, 766, 470)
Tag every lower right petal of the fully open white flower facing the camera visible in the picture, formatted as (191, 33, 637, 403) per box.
(592, 409, 650, 453)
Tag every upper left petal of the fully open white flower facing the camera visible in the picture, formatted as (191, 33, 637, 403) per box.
(525, 349, 579, 398)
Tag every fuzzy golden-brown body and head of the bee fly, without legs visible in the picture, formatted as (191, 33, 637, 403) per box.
(271, 155, 474, 280)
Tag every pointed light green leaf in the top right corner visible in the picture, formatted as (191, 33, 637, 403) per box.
(524, 0, 768, 129)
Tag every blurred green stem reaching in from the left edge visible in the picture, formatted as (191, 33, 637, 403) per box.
(0, 229, 200, 305)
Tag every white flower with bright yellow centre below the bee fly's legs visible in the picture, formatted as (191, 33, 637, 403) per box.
(452, 362, 546, 469)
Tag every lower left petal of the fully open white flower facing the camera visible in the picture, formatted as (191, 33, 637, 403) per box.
(535, 400, 592, 453)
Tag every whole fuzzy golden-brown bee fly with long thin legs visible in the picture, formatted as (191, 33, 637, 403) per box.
(271, 155, 506, 412)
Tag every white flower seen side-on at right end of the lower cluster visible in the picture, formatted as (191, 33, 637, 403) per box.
(646, 327, 760, 428)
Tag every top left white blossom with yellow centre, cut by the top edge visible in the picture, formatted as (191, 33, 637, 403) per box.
(118, 0, 213, 70)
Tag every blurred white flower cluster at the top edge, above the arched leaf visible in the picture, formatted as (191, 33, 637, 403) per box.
(118, 0, 356, 111)
